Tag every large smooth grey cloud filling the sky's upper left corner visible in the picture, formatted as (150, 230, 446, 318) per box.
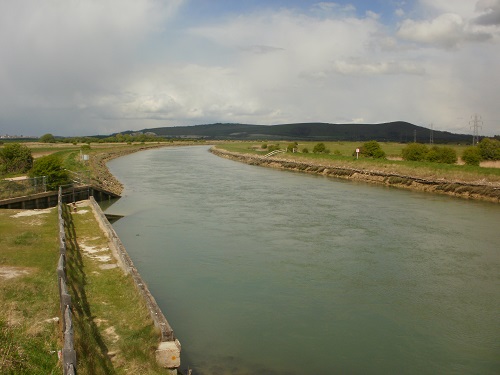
(0, 0, 181, 134)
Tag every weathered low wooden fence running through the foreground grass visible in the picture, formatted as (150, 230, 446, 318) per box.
(57, 188, 76, 375)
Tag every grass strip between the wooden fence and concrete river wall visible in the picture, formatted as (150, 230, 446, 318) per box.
(60, 207, 164, 374)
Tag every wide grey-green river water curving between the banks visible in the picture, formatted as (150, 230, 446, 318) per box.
(107, 146, 500, 375)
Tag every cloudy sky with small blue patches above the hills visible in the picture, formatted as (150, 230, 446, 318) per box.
(0, 0, 500, 136)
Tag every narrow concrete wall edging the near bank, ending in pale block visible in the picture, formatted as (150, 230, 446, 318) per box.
(90, 197, 181, 374)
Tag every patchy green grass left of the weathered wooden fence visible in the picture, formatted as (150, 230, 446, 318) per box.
(0, 210, 62, 374)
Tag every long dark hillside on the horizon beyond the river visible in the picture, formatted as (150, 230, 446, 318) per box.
(137, 121, 472, 143)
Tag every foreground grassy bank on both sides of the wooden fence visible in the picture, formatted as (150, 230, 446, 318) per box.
(0, 206, 165, 374)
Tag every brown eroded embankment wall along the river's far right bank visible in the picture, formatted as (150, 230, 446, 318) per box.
(210, 147, 500, 203)
